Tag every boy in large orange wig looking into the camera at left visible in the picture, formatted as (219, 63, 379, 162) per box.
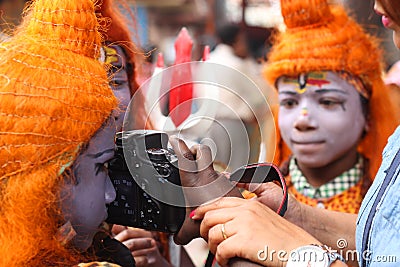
(0, 0, 143, 266)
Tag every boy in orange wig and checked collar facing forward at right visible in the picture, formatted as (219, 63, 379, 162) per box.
(265, 0, 399, 213)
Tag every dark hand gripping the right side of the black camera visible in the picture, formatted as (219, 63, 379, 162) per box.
(169, 136, 242, 245)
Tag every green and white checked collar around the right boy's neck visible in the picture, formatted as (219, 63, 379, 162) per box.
(289, 157, 364, 199)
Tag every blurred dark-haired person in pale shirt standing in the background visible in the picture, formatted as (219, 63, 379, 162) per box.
(208, 23, 276, 171)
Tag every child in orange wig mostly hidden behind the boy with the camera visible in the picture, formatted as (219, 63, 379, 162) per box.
(100, 0, 171, 267)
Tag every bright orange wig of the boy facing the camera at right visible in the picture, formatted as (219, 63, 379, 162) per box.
(264, 0, 399, 178)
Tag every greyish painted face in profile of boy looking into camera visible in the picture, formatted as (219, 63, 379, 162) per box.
(61, 119, 116, 250)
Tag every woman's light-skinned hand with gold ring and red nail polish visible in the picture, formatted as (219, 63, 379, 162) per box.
(192, 197, 320, 266)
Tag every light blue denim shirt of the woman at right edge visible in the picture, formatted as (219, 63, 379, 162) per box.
(356, 126, 400, 267)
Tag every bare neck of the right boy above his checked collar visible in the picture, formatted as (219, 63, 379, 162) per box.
(297, 148, 358, 187)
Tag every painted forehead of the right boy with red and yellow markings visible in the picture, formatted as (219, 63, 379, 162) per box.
(277, 71, 356, 94)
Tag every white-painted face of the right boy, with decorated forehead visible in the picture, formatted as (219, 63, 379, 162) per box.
(277, 71, 366, 168)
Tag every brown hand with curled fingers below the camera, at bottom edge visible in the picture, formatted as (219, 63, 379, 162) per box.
(112, 225, 171, 267)
